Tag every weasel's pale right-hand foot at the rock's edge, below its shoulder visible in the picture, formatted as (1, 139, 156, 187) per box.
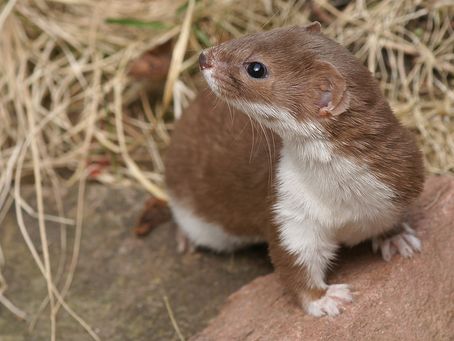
(372, 223, 421, 262)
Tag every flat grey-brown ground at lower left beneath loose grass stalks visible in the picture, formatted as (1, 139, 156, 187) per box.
(0, 184, 272, 341)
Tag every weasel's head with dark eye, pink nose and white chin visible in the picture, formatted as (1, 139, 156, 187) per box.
(199, 22, 349, 135)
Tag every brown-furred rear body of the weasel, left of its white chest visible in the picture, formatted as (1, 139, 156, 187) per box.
(165, 91, 281, 236)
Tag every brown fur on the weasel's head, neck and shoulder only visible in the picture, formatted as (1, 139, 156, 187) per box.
(201, 26, 424, 206)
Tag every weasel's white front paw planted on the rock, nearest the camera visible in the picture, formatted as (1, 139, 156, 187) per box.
(306, 284, 353, 317)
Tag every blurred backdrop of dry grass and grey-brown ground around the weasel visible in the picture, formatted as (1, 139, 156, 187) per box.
(0, 0, 454, 340)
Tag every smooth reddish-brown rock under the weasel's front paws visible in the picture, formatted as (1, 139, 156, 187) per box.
(192, 177, 454, 341)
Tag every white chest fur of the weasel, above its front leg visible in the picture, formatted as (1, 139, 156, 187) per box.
(275, 140, 396, 244)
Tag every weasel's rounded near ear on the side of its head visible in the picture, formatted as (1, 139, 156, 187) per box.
(314, 61, 350, 117)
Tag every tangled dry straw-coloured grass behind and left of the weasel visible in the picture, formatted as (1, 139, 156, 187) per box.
(0, 0, 454, 339)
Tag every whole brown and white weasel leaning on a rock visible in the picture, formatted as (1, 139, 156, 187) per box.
(165, 22, 424, 316)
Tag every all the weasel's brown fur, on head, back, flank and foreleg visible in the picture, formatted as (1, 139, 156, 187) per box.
(166, 24, 424, 310)
